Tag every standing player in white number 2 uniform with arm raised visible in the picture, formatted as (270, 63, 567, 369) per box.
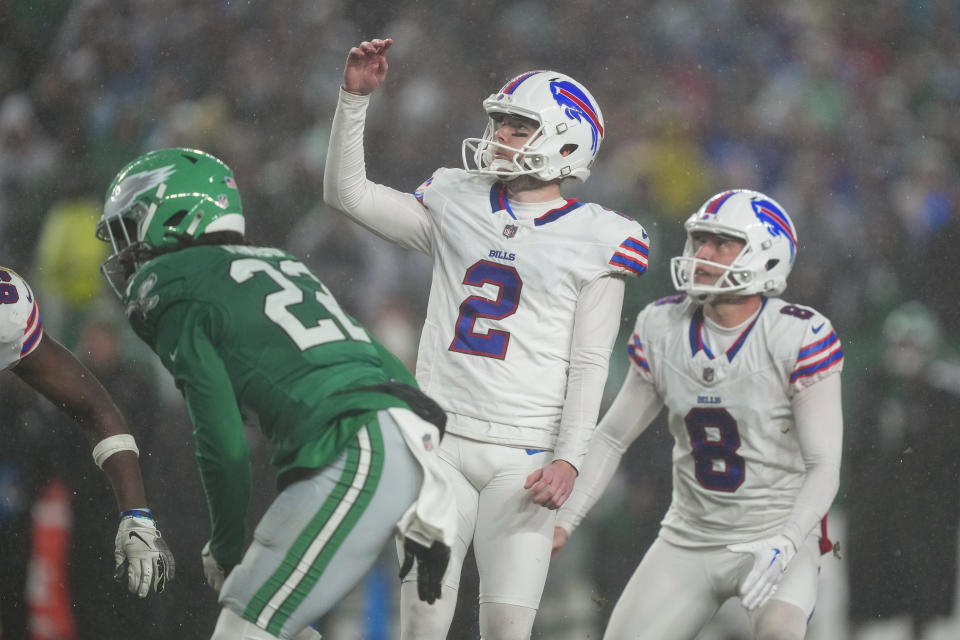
(324, 39, 649, 640)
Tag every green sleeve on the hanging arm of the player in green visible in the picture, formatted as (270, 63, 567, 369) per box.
(157, 309, 251, 567)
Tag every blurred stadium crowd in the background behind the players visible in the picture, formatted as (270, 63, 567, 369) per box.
(0, 0, 960, 640)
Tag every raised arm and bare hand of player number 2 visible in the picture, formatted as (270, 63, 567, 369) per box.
(323, 39, 430, 253)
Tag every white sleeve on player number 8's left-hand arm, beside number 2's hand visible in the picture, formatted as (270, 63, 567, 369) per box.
(557, 367, 663, 534)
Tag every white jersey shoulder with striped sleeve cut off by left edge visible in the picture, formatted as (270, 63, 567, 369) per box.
(0, 267, 43, 370)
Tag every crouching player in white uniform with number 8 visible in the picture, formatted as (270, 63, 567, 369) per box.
(554, 190, 843, 640)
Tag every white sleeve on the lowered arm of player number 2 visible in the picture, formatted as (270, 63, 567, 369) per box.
(554, 276, 625, 469)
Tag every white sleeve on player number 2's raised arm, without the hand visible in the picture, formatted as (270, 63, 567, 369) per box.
(323, 89, 430, 253)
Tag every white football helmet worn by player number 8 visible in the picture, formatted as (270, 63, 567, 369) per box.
(670, 189, 797, 301)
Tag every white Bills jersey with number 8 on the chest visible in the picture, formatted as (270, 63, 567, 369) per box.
(627, 295, 843, 547)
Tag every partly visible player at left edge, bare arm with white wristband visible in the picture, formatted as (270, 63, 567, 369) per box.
(0, 267, 174, 598)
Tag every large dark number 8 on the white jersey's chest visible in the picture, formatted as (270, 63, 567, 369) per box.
(684, 407, 746, 493)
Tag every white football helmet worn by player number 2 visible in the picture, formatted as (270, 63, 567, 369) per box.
(462, 71, 603, 182)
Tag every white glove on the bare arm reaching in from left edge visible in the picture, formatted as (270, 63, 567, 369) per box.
(113, 509, 176, 598)
